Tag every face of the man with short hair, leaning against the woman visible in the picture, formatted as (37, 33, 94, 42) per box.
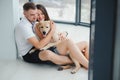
(24, 9, 37, 22)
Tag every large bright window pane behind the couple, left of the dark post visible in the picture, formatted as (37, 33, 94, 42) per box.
(33, 0, 76, 22)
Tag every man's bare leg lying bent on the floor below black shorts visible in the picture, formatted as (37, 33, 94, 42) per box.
(39, 50, 73, 65)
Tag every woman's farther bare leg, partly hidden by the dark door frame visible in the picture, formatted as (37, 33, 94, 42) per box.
(76, 41, 89, 60)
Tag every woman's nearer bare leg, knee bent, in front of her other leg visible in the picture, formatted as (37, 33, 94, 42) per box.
(57, 39, 88, 68)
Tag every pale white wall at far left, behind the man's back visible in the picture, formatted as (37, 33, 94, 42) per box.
(0, 0, 19, 60)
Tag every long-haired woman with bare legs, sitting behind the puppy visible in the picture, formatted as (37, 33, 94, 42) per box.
(35, 4, 89, 68)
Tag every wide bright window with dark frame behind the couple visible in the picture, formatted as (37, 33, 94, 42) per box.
(19, 0, 91, 26)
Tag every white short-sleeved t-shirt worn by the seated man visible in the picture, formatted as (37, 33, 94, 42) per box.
(15, 18, 36, 56)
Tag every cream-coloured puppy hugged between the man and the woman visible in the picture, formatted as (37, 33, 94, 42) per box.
(31, 21, 80, 74)
